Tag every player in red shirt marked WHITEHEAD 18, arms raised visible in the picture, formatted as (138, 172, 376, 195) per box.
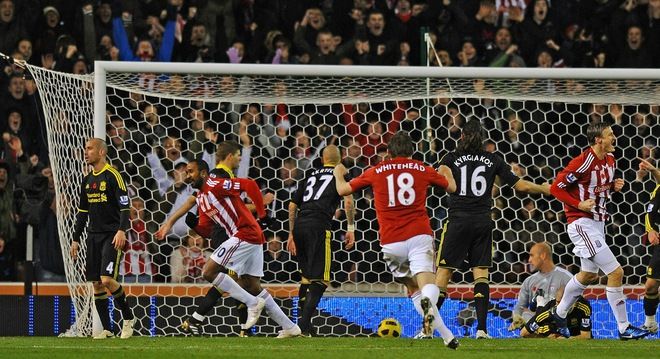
(334, 131, 458, 349)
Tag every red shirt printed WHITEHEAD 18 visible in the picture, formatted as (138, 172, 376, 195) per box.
(350, 157, 448, 244)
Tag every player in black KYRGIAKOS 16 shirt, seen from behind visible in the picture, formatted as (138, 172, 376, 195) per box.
(435, 120, 550, 339)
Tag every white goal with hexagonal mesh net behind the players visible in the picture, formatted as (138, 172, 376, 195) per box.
(29, 62, 660, 337)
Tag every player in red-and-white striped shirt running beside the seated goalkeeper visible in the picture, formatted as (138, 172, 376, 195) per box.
(550, 122, 649, 340)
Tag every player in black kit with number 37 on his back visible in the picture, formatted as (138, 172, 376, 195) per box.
(287, 145, 355, 336)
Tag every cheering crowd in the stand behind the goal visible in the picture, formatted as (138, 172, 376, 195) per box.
(0, 0, 660, 284)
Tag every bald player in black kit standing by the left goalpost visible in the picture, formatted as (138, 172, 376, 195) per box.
(71, 138, 135, 339)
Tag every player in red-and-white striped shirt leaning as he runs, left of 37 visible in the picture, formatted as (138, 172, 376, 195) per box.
(186, 160, 301, 338)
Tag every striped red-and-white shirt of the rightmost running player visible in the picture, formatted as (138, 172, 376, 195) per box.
(550, 148, 615, 223)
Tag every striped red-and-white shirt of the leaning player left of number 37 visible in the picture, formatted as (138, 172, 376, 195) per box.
(195, 174, 266, 244)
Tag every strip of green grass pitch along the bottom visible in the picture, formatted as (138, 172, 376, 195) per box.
(0, 337, 660, 359)
